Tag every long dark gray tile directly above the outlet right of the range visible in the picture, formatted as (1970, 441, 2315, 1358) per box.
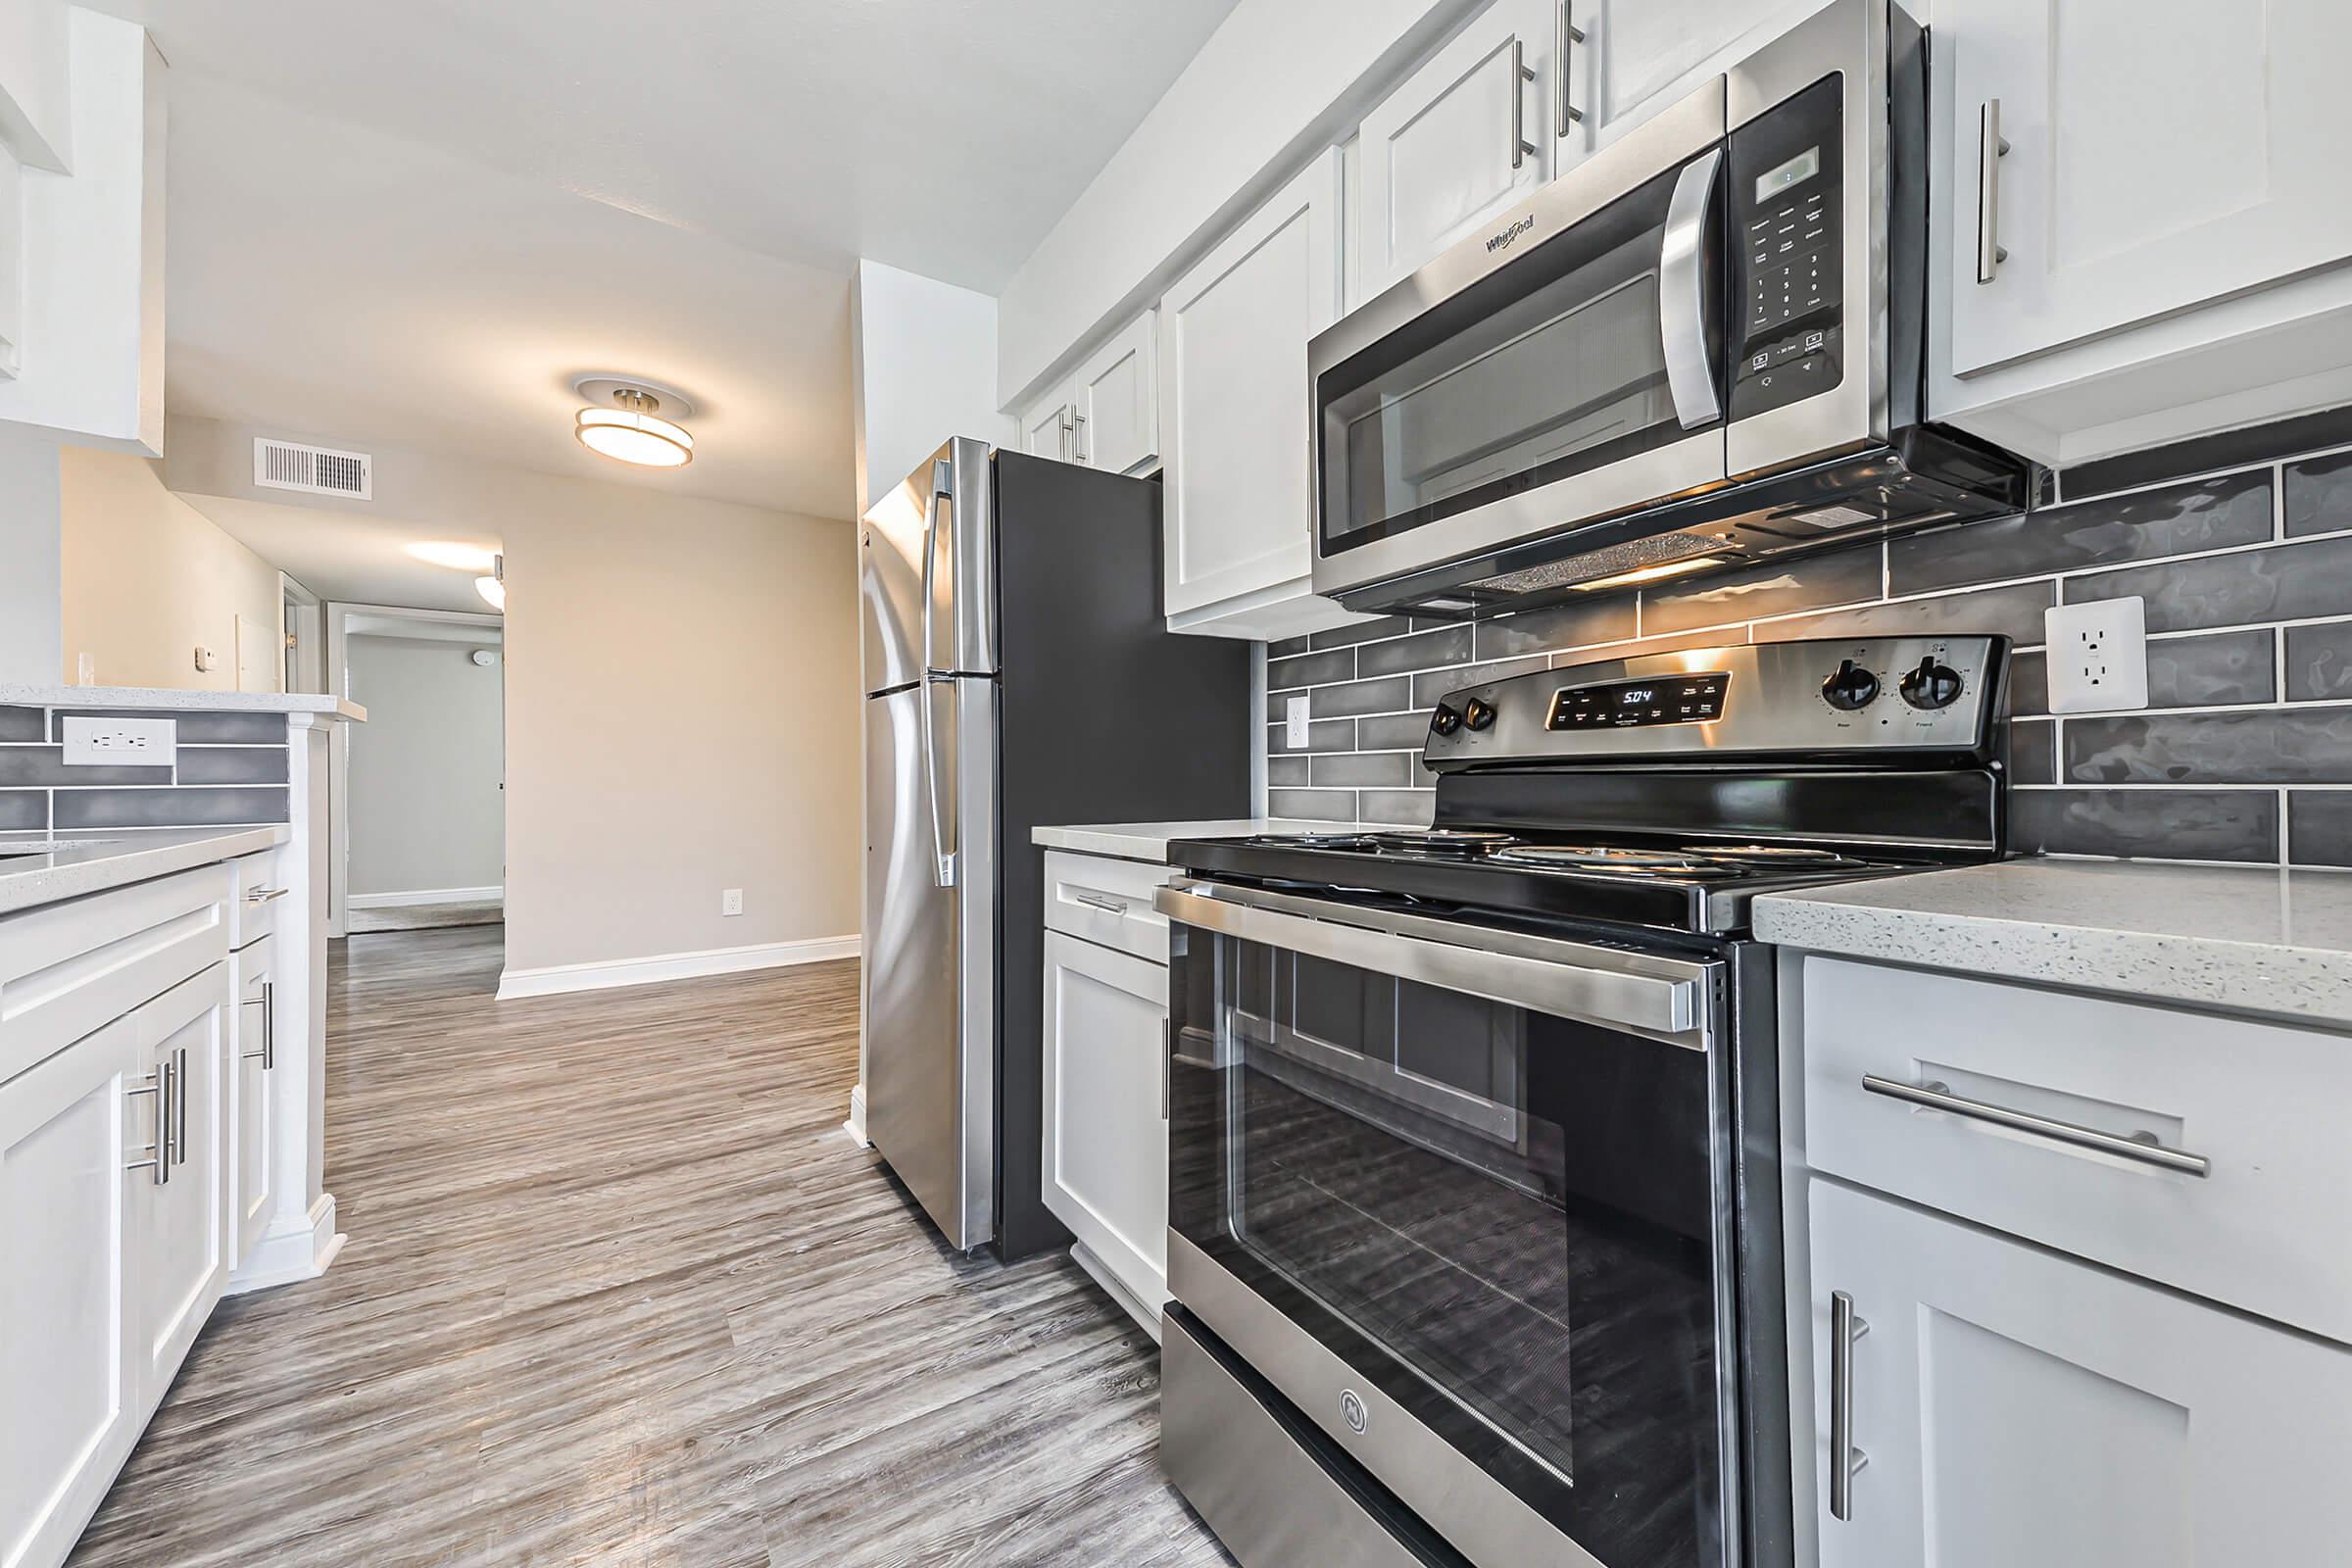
(1886, 470, 2270, 592)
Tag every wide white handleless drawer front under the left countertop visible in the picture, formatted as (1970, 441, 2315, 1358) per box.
(0, 865, 228, 1081)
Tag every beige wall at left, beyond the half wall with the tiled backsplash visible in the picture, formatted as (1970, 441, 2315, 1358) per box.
(59, 447, 284, 691)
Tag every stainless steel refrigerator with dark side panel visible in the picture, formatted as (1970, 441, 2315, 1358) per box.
(858, 440, 1250, 1257)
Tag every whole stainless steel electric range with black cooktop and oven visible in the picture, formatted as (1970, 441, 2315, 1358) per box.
(1157, 637, 2009, 1568)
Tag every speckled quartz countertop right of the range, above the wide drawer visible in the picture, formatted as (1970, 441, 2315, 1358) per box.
(1754, 860, 2352, 1025)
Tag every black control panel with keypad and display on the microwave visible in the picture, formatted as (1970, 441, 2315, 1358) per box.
(1729, 75, 1846, 418)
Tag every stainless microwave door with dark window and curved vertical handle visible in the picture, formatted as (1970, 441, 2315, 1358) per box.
(1307, 80, 1727, 595)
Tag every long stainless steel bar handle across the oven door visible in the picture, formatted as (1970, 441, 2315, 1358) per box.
(1152, 886, 1705, 1049)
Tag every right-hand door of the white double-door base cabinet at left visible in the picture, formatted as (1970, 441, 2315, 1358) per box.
(129, 964, 230, 1405)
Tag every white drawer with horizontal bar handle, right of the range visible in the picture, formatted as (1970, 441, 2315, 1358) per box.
(1804, 959, 2352, 1343)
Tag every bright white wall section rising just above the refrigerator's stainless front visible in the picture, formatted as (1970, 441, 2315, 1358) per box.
(849, 261, 1013, 514)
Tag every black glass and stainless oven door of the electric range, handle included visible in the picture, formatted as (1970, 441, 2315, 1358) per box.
(1157, 882, 1739, 1568)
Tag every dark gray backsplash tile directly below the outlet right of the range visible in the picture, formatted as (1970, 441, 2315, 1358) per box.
(2065, 708, 2352, 783)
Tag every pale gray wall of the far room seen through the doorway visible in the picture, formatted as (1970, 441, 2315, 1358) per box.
(343, 635, 506, 901)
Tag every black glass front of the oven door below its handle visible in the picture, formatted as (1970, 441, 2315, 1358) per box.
(1171, 931, 1722, 1568)
